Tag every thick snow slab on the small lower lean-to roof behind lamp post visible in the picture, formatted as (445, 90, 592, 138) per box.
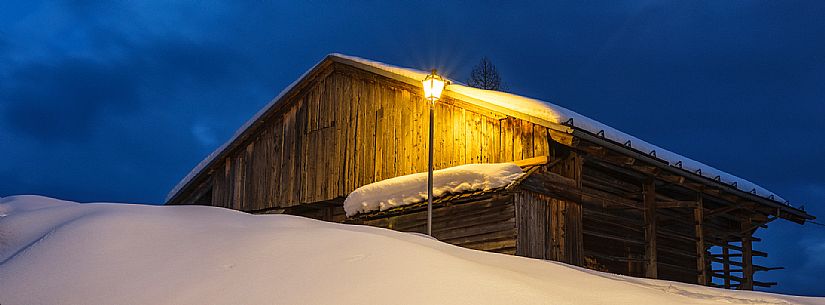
(344, 163, 524, 216)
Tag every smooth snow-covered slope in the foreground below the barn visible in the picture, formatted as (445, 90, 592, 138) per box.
(0, 196, 825, 305)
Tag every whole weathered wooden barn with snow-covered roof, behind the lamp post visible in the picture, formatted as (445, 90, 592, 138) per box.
(167, 54, 814, 289)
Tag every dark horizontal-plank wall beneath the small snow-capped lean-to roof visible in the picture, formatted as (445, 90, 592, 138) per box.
(348, 194, 516, 254)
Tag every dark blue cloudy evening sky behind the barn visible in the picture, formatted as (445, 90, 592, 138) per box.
(0, 0, 825, 295)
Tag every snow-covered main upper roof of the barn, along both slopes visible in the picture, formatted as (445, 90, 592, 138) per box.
(166, 53, 788, 208)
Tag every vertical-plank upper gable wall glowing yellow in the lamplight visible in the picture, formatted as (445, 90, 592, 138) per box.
(182, 64, 548, 211)
